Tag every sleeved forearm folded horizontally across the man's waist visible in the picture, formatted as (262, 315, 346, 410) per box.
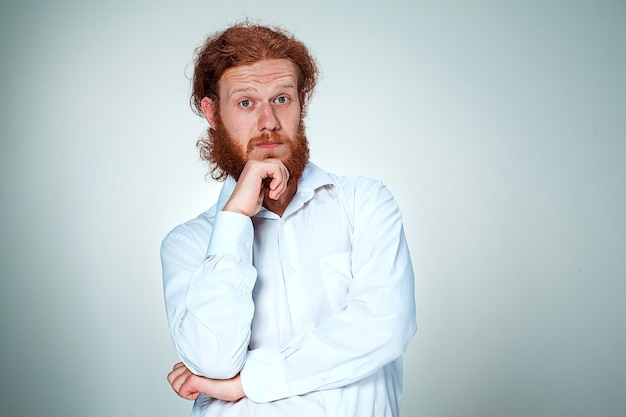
(241, 244, 416, 402)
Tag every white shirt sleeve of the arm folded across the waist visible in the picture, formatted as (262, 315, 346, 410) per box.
(241, 181, 416, 402)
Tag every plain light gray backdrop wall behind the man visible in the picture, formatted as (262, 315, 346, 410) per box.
(0, 0, 626, 417)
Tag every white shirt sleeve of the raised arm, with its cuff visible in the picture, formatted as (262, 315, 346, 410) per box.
(161, 212, 256, 379)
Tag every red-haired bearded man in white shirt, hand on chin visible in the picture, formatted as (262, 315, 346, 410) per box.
(161, 23, 416, 417)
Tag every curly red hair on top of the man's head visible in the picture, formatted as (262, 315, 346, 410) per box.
(191, 21, 318, 115)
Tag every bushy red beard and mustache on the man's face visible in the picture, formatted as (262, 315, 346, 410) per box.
(197, 115, 309, 183)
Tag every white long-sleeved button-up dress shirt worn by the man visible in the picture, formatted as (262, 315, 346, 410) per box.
(161, 163, 416, 417)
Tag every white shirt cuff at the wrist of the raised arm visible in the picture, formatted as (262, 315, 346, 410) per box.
(206, 211, 254, 262)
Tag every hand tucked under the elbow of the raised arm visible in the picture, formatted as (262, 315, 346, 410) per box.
(167, 362, 246, 401)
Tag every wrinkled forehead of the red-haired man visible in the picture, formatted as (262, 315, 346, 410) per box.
(218, 59, 298, 98)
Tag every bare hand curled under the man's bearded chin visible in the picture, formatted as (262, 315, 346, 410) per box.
(224, 158, 289, 217)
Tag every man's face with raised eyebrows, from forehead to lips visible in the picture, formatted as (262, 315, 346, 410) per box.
(203, 59, 302, 161)
